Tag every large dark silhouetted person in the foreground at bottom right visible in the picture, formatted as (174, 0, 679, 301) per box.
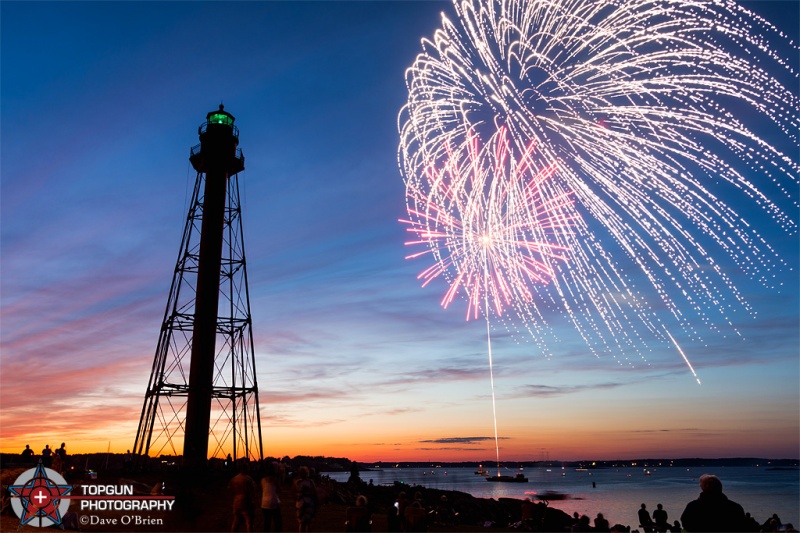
(681, 474, 747, 532)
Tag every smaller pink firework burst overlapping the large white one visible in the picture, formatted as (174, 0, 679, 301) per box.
(401, 128, 577, 320)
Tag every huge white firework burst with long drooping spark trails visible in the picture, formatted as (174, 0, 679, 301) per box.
(398, 0, 800, 378)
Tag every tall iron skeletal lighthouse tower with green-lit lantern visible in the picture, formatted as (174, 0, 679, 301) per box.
(133, 105, 263, 467)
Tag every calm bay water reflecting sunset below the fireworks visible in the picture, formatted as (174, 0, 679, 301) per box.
(328, 465, 800, 527)
